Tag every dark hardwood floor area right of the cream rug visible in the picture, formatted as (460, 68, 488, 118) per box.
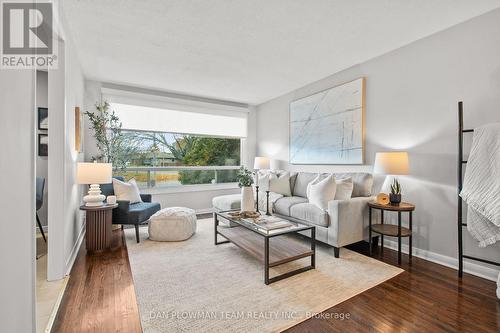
(287, 243, 500, 333)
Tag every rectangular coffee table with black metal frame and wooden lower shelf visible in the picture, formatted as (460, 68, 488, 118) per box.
(214, 211, 316, 284)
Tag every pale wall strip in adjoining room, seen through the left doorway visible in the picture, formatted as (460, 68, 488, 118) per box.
(35, 71, 49, 226)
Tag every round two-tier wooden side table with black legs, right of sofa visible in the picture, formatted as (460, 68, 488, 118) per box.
(368, 201, 415, 265)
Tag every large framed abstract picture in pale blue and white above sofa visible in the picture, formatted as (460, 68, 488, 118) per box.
(289, 78, 365, 164)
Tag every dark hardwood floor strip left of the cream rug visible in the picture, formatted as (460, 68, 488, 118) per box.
(52, 226, 142, 333)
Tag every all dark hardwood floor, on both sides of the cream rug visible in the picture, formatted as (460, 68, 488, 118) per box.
(53, 220, 500, 333)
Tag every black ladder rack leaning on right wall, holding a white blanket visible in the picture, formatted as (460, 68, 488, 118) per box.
(457, 102, 500, 277)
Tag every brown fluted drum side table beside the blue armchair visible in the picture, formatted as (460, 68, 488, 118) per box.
(80, 204, 118, 254)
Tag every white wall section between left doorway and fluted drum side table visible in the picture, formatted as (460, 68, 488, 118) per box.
(48, 35, 85, 280)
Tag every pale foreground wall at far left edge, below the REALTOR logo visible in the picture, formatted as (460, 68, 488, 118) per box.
(0, 70, 36, 332)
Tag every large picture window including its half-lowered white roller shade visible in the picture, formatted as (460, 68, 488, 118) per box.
(103, 92, 248, 188)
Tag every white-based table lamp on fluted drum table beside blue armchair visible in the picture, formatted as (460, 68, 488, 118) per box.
(76, 163, 112, 207)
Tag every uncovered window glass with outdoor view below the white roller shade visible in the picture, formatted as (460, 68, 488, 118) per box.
(115, 130, 241, 188)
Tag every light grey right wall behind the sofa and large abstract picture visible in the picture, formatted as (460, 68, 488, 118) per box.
(257, 10, 500, 277)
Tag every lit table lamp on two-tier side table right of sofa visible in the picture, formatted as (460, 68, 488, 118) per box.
(373, 151, 409, 205)
